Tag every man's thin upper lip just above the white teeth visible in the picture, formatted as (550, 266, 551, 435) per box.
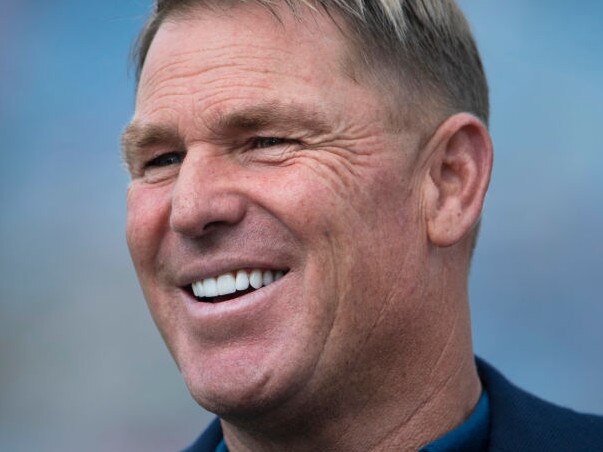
(174, 258, 290, 287)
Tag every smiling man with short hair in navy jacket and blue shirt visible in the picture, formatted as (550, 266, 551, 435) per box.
(123, 0, 603, 451)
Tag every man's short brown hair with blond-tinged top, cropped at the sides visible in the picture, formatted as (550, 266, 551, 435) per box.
(134, 0, 489, 124)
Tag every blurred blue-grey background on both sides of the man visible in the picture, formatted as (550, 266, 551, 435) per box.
(0, 0, 603, 451)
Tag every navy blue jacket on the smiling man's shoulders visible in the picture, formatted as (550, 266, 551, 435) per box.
(185, 358, 603, 452)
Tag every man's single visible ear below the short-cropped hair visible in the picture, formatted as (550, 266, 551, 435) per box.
(423, 113, 492, 247)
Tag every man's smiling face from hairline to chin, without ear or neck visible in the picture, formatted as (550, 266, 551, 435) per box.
(126, 6, 426, 414)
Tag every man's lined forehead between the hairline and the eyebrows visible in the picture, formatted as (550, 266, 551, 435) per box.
(137, 4, 354, 112)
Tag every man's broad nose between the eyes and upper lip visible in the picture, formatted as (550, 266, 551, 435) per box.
(170, 151, 246, 237)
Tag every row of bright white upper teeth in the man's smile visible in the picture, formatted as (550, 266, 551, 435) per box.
(191, 269, 285, 298)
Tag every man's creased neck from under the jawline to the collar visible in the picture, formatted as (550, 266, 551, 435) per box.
(222, 256, 482, 452)
